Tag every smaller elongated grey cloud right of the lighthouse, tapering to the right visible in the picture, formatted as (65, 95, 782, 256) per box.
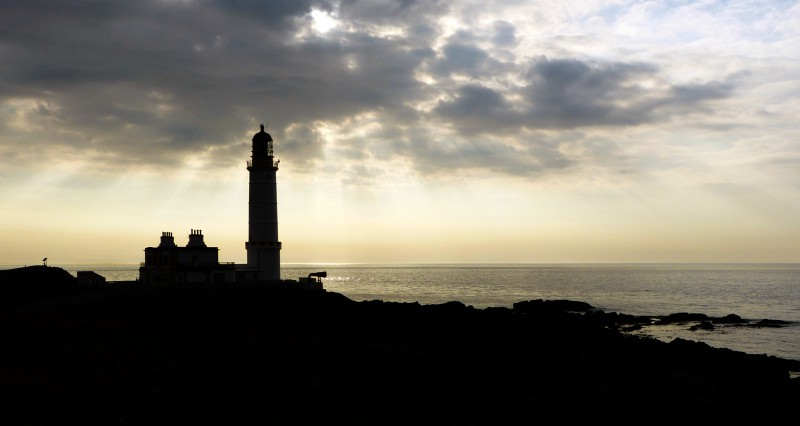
(434, 58, 734, 133)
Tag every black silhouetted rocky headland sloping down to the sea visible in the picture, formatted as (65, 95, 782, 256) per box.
(0, 266, 800, 425)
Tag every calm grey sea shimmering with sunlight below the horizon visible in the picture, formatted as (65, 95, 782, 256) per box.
(7, 263, 800, 360)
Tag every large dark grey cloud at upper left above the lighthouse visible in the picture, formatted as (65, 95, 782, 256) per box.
(0, 1, 426, 170)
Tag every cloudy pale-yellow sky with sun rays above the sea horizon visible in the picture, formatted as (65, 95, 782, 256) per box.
(0, 0, 800, 265)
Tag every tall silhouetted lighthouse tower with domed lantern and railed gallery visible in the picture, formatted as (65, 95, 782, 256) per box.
(245, 124, 281, 281)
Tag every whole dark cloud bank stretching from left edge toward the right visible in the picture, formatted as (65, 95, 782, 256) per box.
(0, 0, 735, 175)
